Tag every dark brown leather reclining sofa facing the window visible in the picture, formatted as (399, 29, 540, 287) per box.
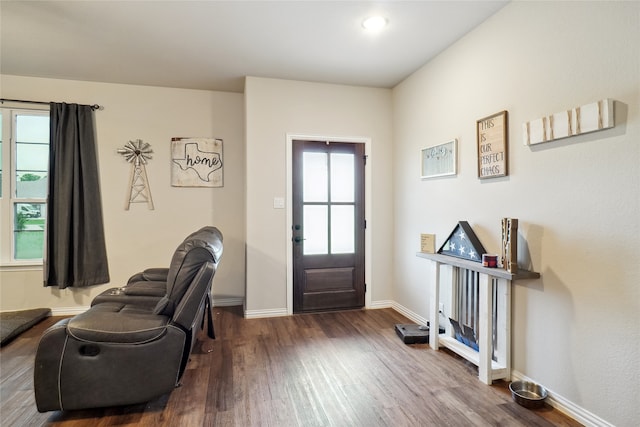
(34, 227, 223, 412)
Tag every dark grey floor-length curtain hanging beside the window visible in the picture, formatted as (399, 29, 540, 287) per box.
(44, 102, 109, 288)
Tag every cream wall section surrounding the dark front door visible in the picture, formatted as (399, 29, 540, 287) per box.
(245, 77, 393, 314)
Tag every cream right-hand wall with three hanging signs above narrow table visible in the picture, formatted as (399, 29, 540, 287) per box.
(393, 2, 640, 426)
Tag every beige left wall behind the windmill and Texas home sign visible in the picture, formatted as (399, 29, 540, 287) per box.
(0, 75, 245, 313)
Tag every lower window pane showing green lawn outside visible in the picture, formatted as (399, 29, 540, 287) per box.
(13, 203, 46, 260)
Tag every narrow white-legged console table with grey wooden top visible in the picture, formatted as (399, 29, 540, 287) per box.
(416, 252, 540, 384)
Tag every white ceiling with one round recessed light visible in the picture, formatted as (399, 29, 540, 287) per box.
(0, 0, 507, 92)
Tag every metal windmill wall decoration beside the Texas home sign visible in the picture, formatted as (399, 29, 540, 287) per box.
(118, 139, 153, 210)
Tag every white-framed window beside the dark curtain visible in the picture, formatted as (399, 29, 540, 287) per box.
(0, 108, 49, 265)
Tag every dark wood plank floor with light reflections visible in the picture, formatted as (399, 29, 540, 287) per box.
(0, 307, 580, 427)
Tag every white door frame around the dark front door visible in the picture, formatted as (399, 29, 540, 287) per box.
(286, 133, 373, 315)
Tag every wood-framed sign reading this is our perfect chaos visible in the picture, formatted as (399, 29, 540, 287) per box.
(476, 111, 509, 179)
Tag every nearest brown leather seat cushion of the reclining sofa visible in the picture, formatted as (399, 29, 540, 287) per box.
(67, 302, 170, 344)
